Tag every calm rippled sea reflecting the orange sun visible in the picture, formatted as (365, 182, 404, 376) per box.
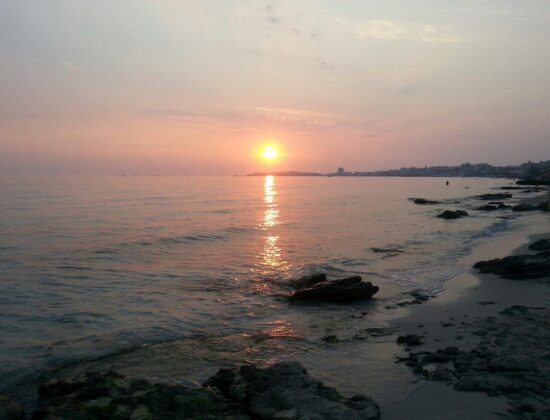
(0, 177, 528, 399)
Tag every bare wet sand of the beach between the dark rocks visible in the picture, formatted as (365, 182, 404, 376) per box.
(381, 213, 550, 420)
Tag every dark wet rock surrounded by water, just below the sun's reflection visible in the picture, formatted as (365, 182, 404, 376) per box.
(289, 276, 378, 303)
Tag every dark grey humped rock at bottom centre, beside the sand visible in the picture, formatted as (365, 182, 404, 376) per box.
(204, 362, 380, 420)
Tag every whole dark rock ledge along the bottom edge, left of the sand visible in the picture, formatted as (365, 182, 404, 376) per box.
(6, 362, 380, 420)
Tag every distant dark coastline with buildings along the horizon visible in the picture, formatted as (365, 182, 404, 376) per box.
(247, 160, 550, 183)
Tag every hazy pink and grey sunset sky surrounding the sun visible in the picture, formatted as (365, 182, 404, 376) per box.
(0, 0, 550, 175)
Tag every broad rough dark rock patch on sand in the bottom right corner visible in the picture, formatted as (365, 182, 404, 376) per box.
(398, 305, 550, 419)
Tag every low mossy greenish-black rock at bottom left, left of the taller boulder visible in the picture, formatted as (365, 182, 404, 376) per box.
(32, 372, 250, 420)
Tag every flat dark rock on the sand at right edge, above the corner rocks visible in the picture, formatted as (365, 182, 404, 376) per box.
(474, 253, 550, 280)
